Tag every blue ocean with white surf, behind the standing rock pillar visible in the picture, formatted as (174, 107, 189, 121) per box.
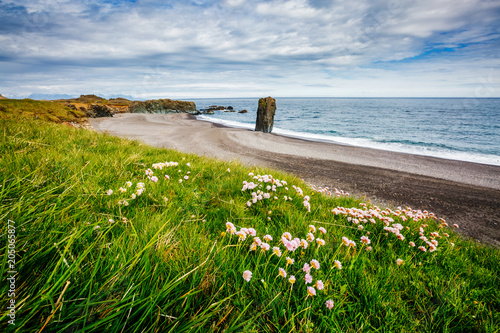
(193, 98, 500, 166)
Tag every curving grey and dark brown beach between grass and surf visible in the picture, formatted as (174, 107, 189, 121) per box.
(90, 114, 500, 246)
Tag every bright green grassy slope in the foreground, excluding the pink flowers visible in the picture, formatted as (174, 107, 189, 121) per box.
(0, 115, 500, 332)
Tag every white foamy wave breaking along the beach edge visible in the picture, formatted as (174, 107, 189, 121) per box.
(197, 116, 500, 166)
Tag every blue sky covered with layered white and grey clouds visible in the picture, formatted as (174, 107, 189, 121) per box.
(0, 0, 500, 99)
